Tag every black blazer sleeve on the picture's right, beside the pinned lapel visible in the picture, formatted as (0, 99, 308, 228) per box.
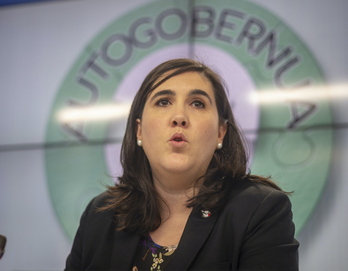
(238, 191, 299, 271)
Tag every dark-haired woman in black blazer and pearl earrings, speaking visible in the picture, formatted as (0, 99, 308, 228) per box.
(66, 59, 298, 271)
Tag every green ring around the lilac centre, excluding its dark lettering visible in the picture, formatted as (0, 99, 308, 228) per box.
(45, 0, 332, 242)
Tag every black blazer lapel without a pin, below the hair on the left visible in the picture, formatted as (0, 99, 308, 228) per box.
(110, 231, 141, 270)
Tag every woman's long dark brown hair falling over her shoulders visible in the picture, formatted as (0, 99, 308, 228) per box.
(102, 59, 280, 234)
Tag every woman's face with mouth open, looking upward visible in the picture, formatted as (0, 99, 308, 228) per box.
(137, 72, 226, 184)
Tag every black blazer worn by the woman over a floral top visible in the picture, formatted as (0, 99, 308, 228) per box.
(65, 181, 299, 271)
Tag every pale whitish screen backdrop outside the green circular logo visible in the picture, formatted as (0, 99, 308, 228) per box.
(0, 0, 348, 271)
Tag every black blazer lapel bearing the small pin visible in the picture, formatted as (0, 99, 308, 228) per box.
(167, 208, 219, 270)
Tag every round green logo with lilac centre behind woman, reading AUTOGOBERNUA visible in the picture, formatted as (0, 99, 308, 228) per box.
(45, 0, 332, 242)
